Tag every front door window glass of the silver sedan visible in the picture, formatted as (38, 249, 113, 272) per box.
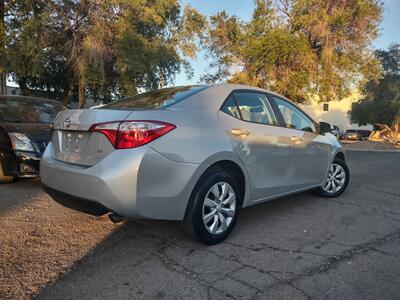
(273, 97, 317, 133)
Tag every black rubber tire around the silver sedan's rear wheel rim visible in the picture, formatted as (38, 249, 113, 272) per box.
(182, 170, 243, 245)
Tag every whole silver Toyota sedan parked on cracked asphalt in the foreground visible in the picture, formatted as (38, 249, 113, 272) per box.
(40, 84, 350, 244)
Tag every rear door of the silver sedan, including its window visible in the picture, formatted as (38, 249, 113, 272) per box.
(219, 91, 293, 200)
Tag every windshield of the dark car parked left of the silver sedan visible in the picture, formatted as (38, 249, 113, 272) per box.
(0, 98, 67, 123)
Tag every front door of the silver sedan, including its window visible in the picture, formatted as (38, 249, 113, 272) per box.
(270, 95, 330, 189)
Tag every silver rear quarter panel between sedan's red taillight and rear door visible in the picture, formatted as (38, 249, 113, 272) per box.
(127, 107, 251, 206)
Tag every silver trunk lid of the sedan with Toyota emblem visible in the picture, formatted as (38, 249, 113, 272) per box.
(52, 109, 131, 166)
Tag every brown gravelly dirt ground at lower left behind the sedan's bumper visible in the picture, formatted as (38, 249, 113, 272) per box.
(0, 179, 118, 299)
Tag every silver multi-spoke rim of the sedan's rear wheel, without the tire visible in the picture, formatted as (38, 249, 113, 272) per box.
(202, 182, 236, 235)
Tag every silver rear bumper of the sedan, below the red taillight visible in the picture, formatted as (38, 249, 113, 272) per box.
(40, 143, 198, 220)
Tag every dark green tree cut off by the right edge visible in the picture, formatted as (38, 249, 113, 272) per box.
(350, 44, 400, 144)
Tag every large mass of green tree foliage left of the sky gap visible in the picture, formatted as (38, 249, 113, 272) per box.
(6, 0, 205, 106)
